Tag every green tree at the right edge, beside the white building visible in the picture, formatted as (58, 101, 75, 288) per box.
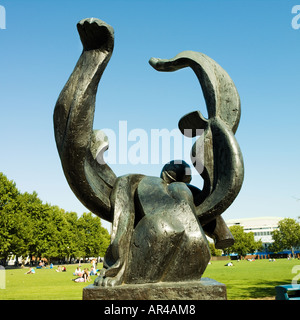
(270, 218, 300, 256)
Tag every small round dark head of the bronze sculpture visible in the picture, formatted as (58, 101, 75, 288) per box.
(160, 160, 192, 183)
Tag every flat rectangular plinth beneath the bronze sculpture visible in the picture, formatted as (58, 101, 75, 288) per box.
(83, 278, 227, 300)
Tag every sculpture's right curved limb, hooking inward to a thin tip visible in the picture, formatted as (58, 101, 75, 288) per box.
(149, 51, 244, 225)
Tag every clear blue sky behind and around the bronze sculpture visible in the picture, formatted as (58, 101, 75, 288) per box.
(0, 0, 300, 230)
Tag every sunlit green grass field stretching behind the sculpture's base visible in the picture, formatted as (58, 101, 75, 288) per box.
(0, 259, 300, 300)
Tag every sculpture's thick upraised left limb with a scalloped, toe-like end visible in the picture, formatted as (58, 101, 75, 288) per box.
(54, 18, 116, 221)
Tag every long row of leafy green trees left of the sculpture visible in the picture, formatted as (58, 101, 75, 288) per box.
(0, 172, 110, 265)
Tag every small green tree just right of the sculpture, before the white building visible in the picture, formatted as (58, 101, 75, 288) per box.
(224, 226, 262, 256)
